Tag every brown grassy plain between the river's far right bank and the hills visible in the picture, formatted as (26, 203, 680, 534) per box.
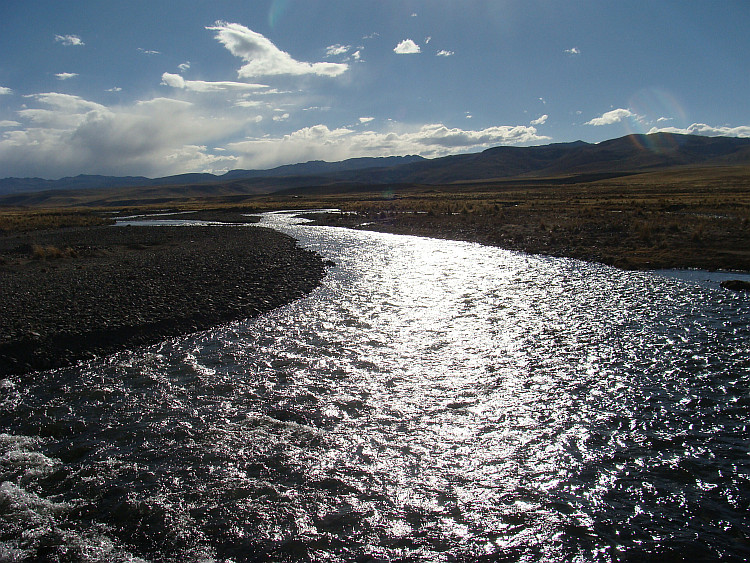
(0, 166, 750, 271)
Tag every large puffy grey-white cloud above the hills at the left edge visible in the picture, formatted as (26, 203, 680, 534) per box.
(0, 92, 248, 178)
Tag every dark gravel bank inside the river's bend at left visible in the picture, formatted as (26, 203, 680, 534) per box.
(0, 226, 325, 376)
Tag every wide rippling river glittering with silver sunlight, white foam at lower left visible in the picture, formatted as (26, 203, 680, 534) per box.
(0, 213, 750, 562)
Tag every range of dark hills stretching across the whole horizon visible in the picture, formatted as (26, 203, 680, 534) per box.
(0, 133, 750, 206)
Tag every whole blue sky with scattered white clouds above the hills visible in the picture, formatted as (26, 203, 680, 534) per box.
(0, 0, 750, 179)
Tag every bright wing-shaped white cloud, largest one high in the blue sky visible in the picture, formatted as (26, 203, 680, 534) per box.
(206, 22, 349, 78)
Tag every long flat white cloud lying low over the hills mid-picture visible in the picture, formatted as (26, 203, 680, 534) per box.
(227, 123, 549, 168)
